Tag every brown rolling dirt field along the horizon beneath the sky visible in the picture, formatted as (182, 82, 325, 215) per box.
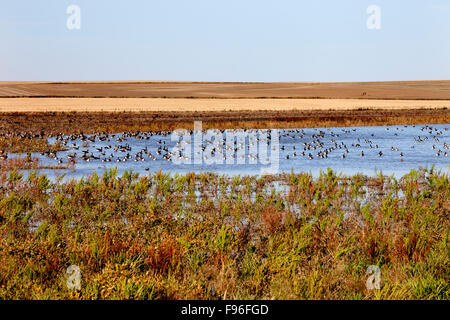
(0, 80, 450, 100)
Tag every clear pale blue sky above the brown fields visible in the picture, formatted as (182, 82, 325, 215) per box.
(0, 0, 450, 81)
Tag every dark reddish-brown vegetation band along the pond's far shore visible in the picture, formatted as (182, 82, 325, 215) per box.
(0, 109, 450, 138)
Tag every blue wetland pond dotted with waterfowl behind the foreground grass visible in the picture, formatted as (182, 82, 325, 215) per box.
(10, 124, 450, 180)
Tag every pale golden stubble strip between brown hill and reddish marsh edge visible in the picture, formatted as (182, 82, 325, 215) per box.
(0, 98, 450, 112)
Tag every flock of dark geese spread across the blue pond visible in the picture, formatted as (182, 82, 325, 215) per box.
(0, 125, 450, 171)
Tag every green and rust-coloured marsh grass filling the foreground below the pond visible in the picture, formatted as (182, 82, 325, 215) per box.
(0, 169, 450, 299)
